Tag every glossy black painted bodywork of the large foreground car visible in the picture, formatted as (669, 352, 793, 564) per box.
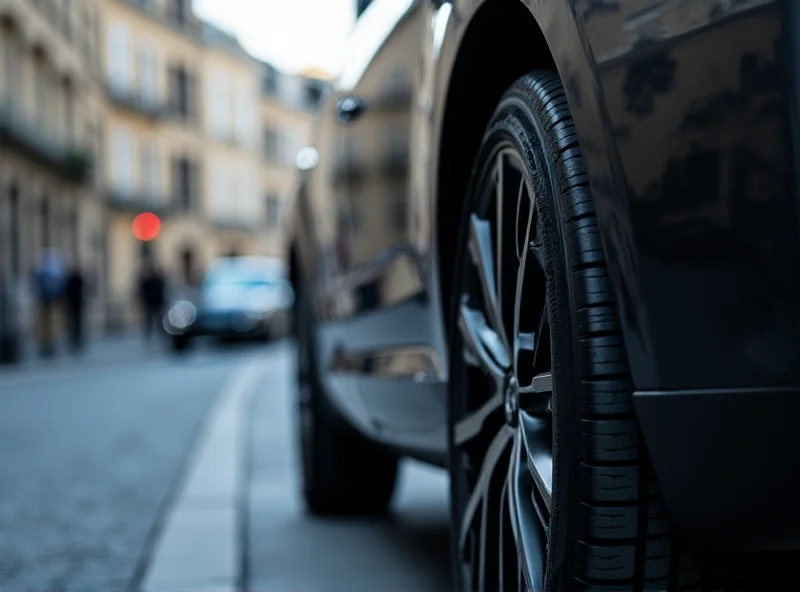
(290, 0, 800, 544)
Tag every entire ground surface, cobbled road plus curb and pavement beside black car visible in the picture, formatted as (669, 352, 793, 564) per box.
(0, 339, 451, 592)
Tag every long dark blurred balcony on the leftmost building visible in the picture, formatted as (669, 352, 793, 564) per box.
(0, 102, 94, 184)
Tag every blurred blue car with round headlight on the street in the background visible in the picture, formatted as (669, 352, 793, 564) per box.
(164, 257, 293, 351)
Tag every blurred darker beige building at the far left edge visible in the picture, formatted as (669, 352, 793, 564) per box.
(0, 0, 107, 333)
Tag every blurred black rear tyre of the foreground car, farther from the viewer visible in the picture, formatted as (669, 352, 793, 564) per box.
(295, 282, 398, 515)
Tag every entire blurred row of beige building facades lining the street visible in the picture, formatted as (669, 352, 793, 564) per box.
(0, 0, 326, 335)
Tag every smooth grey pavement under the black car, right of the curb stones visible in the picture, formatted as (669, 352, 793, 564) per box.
(246, 348, 453, 592)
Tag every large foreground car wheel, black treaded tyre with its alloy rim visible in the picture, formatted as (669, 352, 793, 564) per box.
(449, 71, 702, 590)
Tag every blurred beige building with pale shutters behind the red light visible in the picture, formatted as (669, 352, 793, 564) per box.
(99, 0, 264, 325)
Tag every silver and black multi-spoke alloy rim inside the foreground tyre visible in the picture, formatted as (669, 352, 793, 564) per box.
(451, 143, 556, 590)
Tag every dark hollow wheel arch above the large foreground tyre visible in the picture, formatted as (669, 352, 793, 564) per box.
(435, 0, 557, 334)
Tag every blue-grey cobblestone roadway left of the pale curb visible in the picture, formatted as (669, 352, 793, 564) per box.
(0, 342, 266, 592)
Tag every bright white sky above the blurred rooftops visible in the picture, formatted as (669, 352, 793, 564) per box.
(194, 0, 356, 75)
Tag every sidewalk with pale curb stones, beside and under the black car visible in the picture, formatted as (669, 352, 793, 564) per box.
(134, 342, 453, 592)
